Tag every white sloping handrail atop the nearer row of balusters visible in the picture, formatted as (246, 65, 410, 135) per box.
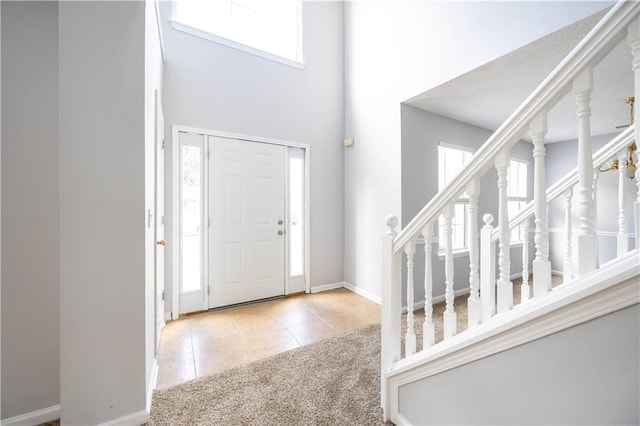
(393, 1, 640, 254)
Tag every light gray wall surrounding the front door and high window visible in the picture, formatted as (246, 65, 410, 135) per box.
(161, 2, 344, 311)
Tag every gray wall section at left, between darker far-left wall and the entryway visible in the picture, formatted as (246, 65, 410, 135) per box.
(58, 2, 147, 424)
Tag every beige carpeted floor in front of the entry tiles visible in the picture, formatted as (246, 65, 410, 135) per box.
(149, 324, 390, 426)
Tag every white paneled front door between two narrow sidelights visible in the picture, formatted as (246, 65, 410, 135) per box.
(209, 136, 286, 308)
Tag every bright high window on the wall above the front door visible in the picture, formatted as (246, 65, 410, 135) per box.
(173, 0, 302, 68)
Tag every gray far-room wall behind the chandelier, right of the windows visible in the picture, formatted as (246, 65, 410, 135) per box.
(545, 134, 637, 271)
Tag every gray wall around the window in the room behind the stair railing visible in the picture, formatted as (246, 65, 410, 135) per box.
(401, 104, 533, 301)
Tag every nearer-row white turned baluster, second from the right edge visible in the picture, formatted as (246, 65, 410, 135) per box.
(573, 67, 598, 276)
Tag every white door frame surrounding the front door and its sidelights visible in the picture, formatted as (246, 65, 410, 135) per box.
(171, 124, 311, 320)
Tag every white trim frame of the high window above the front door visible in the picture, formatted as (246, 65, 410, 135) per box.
(169, 0, 305, 70)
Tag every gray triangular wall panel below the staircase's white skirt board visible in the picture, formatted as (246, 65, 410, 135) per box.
(400, 305, 640, 425)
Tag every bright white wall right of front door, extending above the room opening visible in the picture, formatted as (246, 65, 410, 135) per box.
(345, 0, 611, 295)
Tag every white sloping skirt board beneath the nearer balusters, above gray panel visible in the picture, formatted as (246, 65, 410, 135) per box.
(383, 250, 640, 424)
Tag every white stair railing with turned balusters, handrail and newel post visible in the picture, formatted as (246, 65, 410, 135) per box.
(381, 1, 640, 419)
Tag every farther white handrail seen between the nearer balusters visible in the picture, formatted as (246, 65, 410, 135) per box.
(491, 125, 634, 240)
